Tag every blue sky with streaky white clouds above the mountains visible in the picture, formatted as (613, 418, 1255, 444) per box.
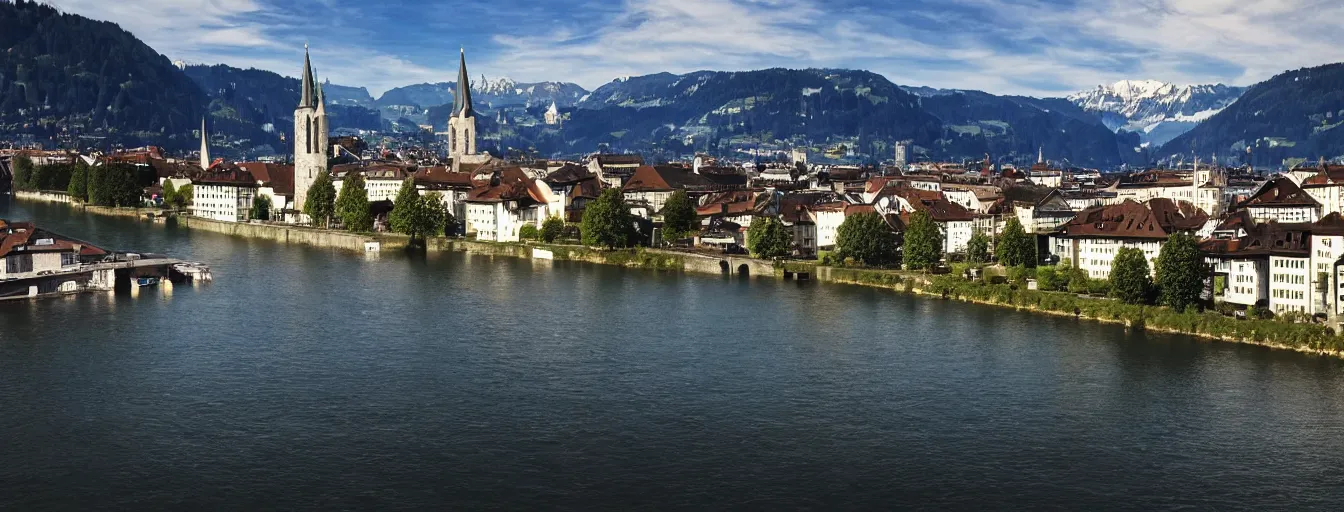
(39, 0, 1344, 97)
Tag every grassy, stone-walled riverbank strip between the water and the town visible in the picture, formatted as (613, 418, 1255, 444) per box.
(16, 192, 1344, 357)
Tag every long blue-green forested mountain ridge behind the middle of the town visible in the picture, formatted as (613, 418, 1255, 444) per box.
(564, 69, 1138, 167)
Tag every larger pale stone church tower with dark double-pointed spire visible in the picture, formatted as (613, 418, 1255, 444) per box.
(293, 44, 331, 215)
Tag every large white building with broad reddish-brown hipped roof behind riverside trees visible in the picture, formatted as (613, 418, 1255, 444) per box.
(1050, 199, 1208, 280)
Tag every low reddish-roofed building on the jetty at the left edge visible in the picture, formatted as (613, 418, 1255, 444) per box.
(0, 219, 108, 281)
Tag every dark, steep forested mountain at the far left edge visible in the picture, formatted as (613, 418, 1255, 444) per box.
(0, 0, 210, 148)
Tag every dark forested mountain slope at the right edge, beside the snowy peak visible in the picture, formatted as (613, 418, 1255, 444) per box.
(1163, 63, 1344, 167)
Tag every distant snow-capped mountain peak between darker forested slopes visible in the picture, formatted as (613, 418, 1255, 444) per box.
(1068, 81, 1246, 148)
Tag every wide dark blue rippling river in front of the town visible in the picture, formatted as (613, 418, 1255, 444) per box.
(0, 199, 1344, 511)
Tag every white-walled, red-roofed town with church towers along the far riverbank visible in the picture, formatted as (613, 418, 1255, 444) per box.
(0, 52, 1344, 324)
